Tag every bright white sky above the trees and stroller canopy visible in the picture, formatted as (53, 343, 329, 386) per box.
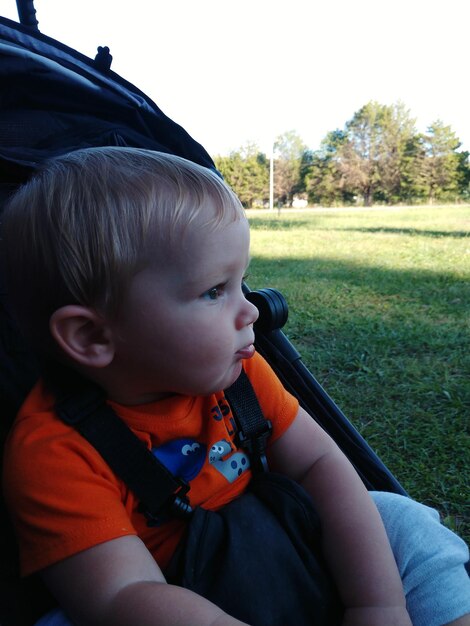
(0, 0, 470, 156)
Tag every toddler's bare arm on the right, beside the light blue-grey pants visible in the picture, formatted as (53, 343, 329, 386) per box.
(269, 409, 411, 626)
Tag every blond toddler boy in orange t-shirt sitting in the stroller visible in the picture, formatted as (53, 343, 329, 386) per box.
(3, 148, 470, 626)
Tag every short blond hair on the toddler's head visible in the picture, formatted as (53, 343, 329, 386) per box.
(2, 147, 244, 347)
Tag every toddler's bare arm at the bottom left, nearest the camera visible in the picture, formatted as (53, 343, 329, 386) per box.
(43, 536, 250, 626)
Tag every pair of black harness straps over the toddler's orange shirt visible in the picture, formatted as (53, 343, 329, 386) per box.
(49, 370, 272, 525)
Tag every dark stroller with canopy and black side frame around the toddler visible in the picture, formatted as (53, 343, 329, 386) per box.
(0, 0, 405, 626)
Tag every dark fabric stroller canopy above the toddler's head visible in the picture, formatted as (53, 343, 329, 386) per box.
(0, 13, 215, 189)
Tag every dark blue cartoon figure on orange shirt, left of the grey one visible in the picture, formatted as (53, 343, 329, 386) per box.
(152, 438, 206, 482)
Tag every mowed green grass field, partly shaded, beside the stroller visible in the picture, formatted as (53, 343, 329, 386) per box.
(248, 205, 470, 541)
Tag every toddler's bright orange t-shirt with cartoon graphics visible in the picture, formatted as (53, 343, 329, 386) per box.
(3, 354, 298, 575)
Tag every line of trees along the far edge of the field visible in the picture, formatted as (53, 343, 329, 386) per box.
(214, 101, 470, 208)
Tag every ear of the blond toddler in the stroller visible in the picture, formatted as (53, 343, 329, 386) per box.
(49, 304, 114, 367)
